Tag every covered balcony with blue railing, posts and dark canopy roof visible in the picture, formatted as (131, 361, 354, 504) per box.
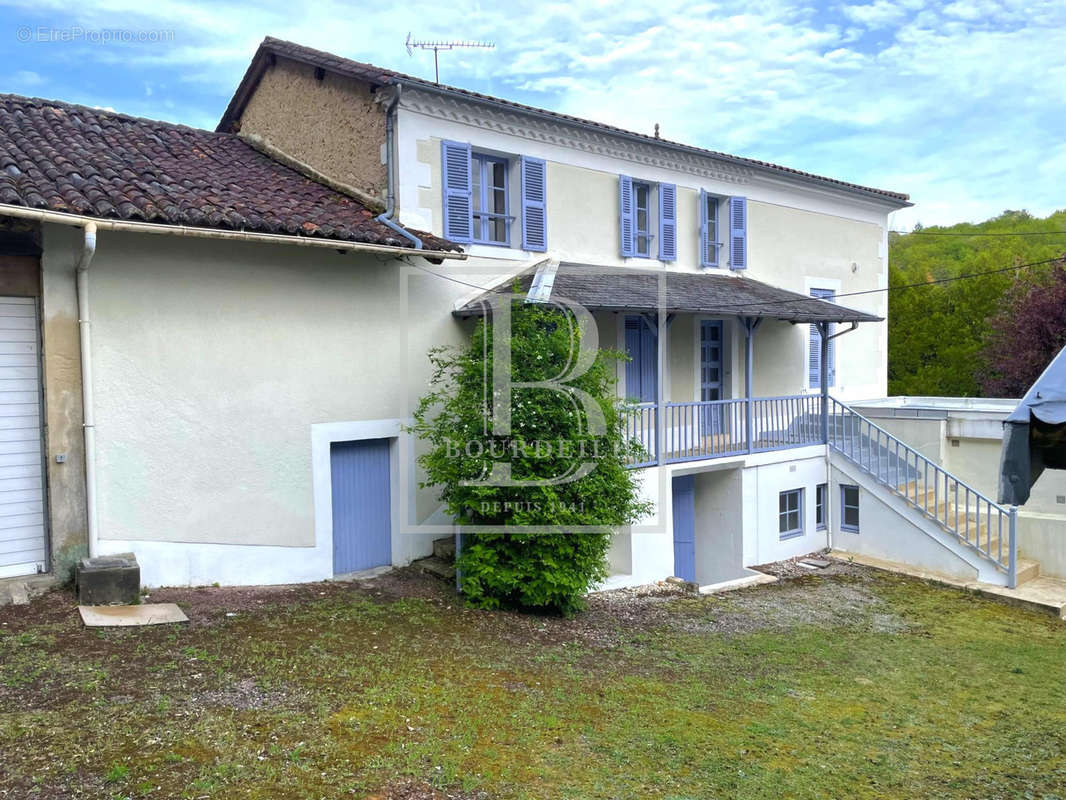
(453, 258, 882, 467)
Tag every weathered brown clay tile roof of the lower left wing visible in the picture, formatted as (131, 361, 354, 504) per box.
(0, 94, 458, 250)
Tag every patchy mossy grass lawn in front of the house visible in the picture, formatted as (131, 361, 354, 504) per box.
(0, 565, 1066, 800)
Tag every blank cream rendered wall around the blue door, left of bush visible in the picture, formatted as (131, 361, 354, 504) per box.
(38, 227, 488, 585)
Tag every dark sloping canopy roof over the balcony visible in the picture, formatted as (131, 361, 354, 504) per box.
(454, 262, 883, 323)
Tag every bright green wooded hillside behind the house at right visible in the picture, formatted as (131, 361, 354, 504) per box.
(888, 211, 1066, 397)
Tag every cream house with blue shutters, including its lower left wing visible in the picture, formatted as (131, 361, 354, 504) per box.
(0, 38, 1025, 597)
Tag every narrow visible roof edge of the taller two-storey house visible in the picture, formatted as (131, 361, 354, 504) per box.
(217, 36, 911, 208)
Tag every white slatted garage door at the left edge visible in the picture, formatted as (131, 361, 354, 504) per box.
(0, 298, 47, 578)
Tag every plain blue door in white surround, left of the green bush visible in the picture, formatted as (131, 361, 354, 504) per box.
(329, 438, 392, 575)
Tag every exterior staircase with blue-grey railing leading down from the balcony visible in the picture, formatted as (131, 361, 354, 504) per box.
(827, 398, 1040, 589)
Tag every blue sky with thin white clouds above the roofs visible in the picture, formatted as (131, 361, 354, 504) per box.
(0, 0, 1066, 230)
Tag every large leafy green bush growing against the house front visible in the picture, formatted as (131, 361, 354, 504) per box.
(413, 302, 650, 614)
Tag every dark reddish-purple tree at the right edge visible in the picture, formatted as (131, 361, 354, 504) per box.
(980, 256, 1066, 397)
